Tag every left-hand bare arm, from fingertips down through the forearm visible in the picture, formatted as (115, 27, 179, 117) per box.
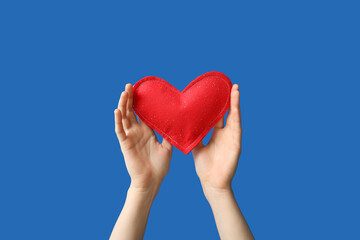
(110, 84, 173, 240)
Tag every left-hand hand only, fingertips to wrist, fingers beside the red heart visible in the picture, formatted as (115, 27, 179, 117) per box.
(114, 84, 173, 190)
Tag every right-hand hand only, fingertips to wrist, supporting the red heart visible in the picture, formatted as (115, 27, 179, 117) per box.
(192, 84, 241, 195)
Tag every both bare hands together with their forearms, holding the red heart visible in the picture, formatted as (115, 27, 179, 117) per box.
(110, 84, 254, 240)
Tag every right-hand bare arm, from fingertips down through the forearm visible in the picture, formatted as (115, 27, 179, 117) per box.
(192, 84, 254, 240)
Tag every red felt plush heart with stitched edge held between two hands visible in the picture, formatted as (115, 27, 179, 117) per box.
(133, 71, 232, 154)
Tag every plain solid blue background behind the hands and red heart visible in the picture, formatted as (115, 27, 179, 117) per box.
(0, 1, 360, 239)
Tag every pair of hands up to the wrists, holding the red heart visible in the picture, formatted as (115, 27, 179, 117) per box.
(114, 84, 241, 199)
